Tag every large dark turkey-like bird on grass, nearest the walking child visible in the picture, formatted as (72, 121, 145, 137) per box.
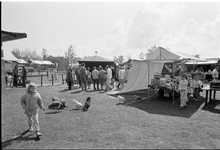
(48, 97, 67, 113)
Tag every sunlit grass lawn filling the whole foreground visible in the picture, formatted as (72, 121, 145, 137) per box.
(2, 85, 220, 149)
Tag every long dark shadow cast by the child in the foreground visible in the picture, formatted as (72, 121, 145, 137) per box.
(2, 130, 40, 148)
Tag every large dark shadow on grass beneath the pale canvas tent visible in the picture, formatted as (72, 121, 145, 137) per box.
(108, 90, 204, 118)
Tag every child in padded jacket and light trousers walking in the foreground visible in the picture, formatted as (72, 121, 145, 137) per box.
(21, 83, 45, 136)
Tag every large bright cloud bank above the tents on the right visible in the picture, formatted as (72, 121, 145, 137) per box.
(65, 3, 220, 60)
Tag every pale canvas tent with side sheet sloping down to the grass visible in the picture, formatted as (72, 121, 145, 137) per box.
(107, 47, 203, 95)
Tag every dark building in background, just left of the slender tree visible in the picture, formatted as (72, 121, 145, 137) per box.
(48, 56, 68, 72)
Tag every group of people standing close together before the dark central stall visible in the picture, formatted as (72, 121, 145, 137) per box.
(66, 63, 131, 91)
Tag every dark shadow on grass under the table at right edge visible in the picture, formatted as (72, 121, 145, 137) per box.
(202, 100, 220, 114)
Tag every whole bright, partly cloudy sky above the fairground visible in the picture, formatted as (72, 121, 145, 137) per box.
(1, 1, 220, 60)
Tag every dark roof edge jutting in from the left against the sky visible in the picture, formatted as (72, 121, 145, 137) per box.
(1, 30, 27, 42)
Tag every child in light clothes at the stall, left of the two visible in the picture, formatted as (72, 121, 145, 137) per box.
(178, 74, 188, 110)
